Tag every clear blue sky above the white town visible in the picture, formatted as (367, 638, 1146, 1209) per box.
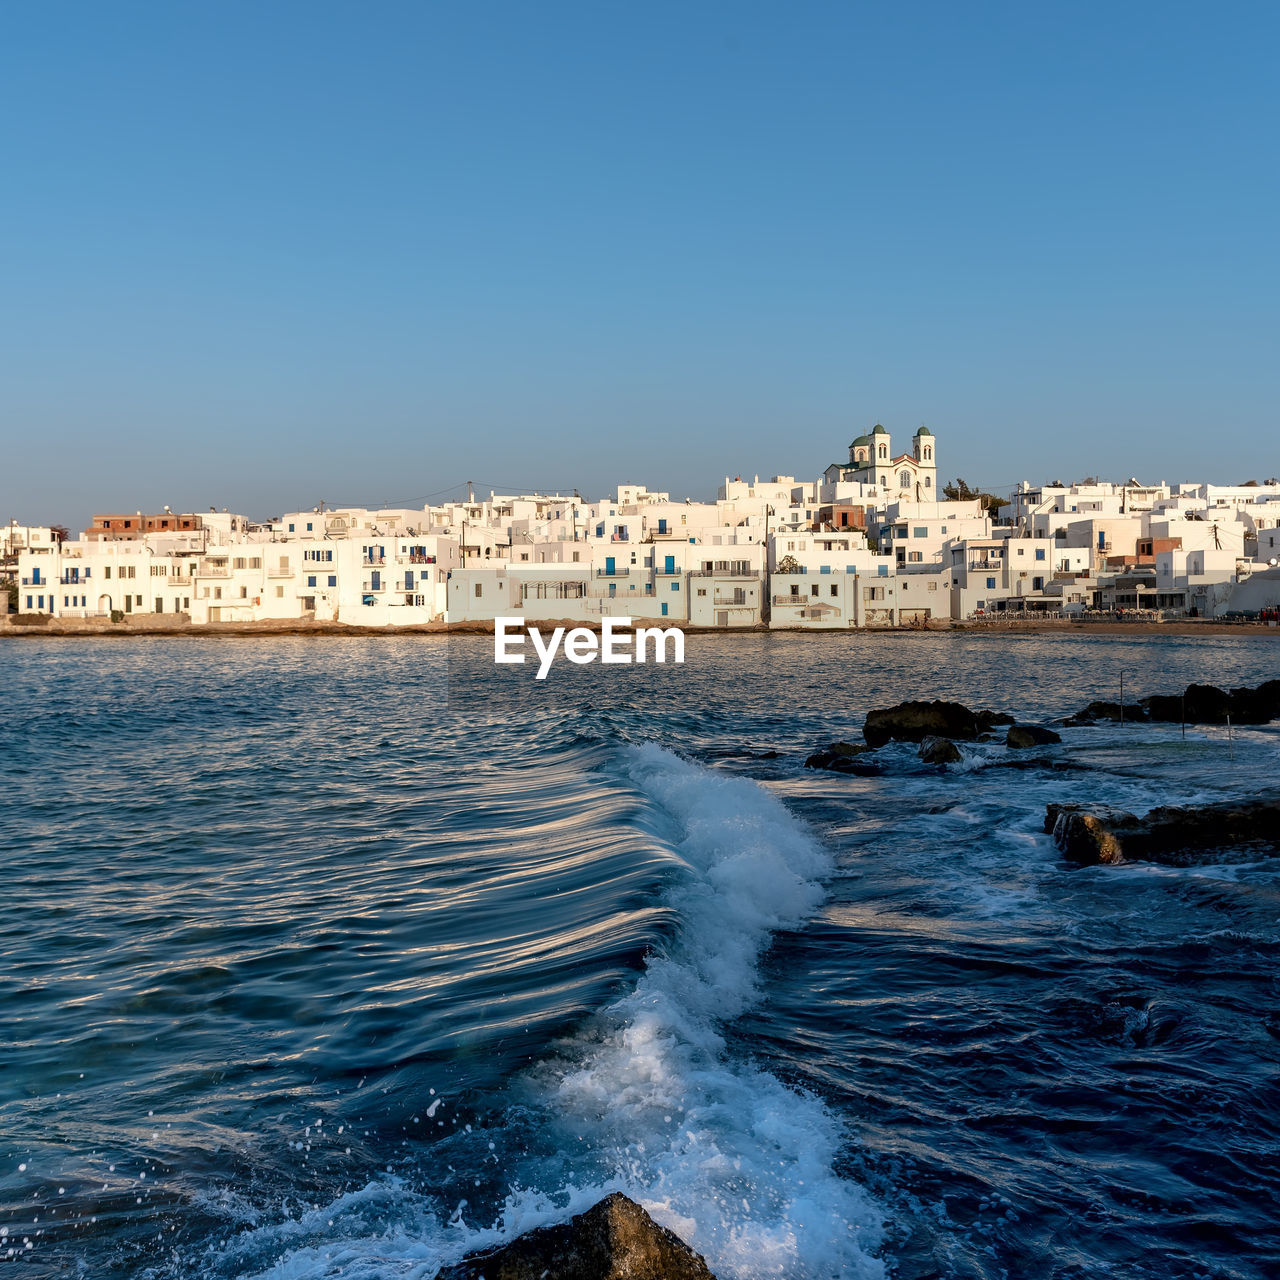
(0, 0, 1280, 527)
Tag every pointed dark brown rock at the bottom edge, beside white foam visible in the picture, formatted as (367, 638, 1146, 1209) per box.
(436, 1192, 716, 1280)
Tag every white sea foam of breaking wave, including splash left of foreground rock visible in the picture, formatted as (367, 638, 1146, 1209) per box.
(197, 746, 884, 1280)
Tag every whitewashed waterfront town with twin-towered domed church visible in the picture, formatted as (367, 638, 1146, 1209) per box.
(0, 424, 1280, 630)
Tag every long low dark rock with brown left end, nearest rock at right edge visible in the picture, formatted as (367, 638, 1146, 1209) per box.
(1044, 795, 1280, 867)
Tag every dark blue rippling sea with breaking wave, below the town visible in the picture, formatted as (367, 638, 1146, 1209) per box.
(0, 631, 1280, 1280)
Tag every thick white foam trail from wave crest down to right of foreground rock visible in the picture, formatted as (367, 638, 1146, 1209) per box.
(524, 746, 883, 1280)
